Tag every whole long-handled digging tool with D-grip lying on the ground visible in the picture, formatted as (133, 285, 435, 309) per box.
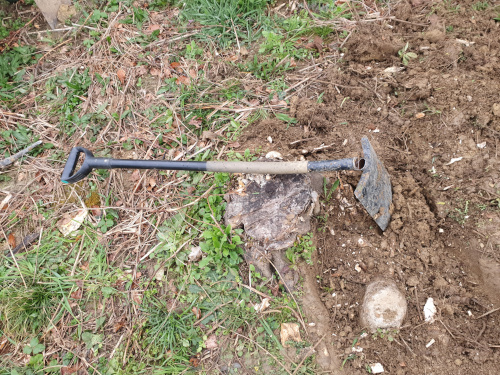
(61, 137, 392, 230)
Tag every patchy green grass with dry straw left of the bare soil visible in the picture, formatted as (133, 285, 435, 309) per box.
(0, 0, 364, 374)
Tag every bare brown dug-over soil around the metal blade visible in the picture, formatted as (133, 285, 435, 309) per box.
(240, 0, 500, 375)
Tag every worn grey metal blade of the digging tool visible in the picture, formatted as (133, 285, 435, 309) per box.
(354, 137, 392, 230)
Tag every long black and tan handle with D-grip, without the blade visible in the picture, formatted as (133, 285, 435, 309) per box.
(61, 147, 363, 184)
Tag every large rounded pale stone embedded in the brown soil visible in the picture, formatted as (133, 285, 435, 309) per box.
(360, 279, 407, 332)
